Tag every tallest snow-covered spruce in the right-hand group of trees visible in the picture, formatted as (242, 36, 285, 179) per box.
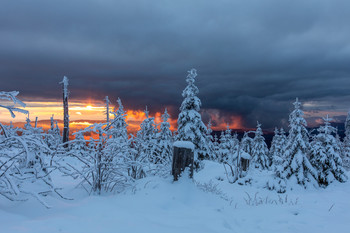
(277, 98, 318, 188)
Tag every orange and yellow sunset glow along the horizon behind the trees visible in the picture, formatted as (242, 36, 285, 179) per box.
(0, 101, 249, 137)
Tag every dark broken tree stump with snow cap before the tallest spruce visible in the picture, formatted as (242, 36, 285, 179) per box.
(171, 141, 194, 181)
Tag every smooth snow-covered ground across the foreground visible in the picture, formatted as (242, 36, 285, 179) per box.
(0, 162, 350, 233)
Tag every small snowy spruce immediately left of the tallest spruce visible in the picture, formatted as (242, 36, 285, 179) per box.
(154, 109, 174, 165)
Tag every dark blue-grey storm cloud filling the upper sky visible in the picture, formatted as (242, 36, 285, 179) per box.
(0, 0, 350, 127)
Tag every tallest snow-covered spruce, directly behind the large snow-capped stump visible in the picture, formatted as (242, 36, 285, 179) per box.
(176, 69, 208, 159)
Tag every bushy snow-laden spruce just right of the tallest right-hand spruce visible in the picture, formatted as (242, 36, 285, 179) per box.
(310, 115, 348, 187)
